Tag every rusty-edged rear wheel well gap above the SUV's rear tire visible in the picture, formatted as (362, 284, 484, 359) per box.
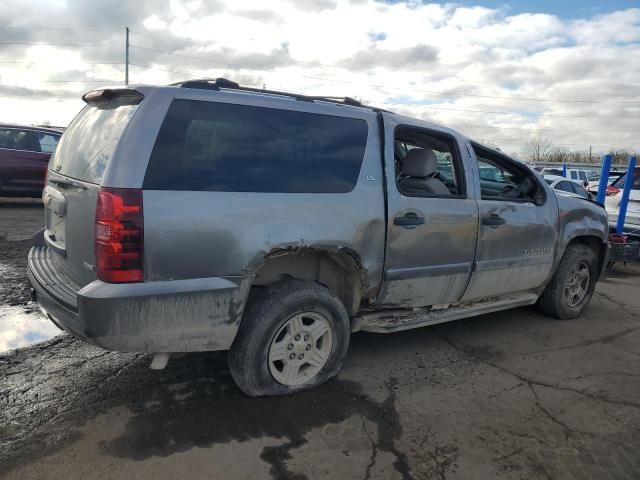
(252, 251, 363, 316)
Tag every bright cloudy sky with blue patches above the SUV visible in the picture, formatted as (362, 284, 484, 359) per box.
(0, 0, 640, 153)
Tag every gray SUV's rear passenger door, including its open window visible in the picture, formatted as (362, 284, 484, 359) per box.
(378, 116, 478, 307)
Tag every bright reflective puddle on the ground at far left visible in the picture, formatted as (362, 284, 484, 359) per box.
(0, 303, 62, 353)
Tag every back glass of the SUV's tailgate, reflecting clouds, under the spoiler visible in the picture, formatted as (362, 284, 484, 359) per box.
(52, 96, 140, 184)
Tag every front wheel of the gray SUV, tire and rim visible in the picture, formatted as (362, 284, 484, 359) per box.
(538, 244, 598, 320)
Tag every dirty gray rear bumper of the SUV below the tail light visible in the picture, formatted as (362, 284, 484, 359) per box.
(28, 247, 251, 352)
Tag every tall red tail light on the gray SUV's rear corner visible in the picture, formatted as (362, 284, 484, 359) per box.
(95, 188, 144, 283)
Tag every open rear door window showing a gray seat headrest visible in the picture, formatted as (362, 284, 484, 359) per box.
(394, 127, 465, 197)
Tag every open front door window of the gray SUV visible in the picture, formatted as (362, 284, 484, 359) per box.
(472, 143, 545, 204)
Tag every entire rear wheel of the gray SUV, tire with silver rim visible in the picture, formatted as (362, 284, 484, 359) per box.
(228, 279, 351, 397)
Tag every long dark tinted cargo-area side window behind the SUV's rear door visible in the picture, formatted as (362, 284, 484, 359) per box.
(144, 100, 368, 193)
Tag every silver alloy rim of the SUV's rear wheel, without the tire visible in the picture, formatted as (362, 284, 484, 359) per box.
(268, 312, 333, 385)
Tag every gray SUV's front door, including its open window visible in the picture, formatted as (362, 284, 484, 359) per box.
(463, 144, 557, 300)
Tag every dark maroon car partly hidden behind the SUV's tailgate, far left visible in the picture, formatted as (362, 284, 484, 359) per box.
(0, 124, 62, 197)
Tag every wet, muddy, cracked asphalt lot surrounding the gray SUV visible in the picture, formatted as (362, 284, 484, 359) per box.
(0, 197, 640, 480)
